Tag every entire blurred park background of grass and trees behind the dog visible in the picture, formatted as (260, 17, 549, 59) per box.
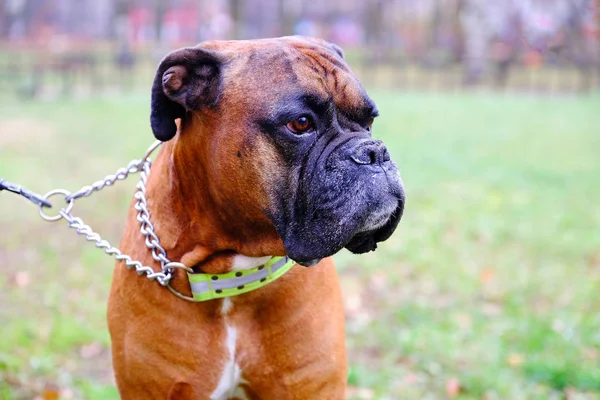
(0, 0, 600, 400)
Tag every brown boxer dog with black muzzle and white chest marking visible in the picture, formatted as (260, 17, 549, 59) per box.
(108, 37, 404, 400)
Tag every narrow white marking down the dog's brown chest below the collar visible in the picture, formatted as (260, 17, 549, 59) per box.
(210, 298, 248, 400)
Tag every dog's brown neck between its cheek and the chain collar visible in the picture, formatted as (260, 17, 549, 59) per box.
(146, 125, 285, 274)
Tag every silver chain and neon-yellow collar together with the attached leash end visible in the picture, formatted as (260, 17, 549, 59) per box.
(0, 141, 294, 302)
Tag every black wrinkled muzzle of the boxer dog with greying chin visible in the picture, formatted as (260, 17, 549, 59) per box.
(274, 134, 405, 266)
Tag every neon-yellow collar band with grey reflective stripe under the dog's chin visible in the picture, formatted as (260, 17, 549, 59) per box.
(187, 256, 295, 302)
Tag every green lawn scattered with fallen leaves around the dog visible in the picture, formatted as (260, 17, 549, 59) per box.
(0, 91, 600, 400)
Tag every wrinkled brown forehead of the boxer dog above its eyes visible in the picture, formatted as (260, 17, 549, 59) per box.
(203, 37, 375, 119)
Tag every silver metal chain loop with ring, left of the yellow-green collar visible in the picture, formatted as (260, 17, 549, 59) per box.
(39, 142, 176, 286)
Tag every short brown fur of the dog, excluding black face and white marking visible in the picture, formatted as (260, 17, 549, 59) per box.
(108, 38, 376, 400)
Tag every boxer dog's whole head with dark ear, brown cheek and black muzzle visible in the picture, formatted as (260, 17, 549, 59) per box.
(150, 37, 404, 265)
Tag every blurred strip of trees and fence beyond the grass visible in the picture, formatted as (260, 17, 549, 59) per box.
(0, 0, 600, 97)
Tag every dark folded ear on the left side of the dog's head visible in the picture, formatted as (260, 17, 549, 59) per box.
(150, 46, 222, 142)
